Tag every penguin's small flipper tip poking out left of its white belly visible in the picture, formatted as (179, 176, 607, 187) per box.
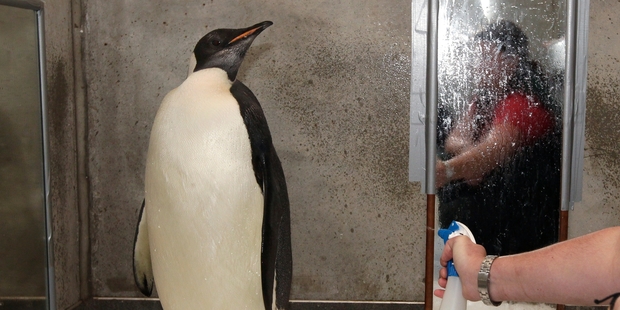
(133, 200, 154, 296)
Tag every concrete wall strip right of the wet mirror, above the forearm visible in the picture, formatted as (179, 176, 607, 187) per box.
(569, 0, 620, 237)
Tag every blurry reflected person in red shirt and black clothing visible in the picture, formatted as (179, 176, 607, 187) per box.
(436, 20, 561, 255)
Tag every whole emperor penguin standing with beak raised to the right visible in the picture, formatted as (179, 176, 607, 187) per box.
(133, 21, 292, 310)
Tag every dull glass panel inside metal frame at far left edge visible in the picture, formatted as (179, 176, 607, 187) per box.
(0, 5, 46, 309)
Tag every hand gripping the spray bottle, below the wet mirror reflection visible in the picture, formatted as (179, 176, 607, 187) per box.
(434, 236, 486, 301)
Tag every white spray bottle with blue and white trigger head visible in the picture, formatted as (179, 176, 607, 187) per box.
(438, 221, 476, 310)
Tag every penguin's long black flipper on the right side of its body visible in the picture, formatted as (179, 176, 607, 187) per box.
(230, 80, 292, 309)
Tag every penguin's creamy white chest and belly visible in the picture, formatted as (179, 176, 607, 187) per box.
(145, 69, 264, 310)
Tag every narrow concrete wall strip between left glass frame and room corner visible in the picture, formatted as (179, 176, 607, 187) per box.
(45, 0, 81, 309)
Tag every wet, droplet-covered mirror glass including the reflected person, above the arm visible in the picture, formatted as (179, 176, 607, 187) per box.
(436, 1, 564, 255)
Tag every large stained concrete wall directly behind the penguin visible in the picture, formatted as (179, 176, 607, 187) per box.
(84, 0, 425, 301)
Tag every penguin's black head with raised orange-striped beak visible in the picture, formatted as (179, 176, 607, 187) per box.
(194, 21, 273, 81)
